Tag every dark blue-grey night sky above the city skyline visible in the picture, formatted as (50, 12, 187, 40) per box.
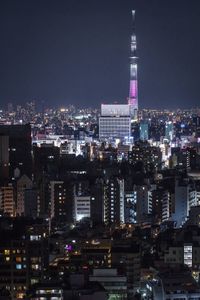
(0, 0, 200, 108)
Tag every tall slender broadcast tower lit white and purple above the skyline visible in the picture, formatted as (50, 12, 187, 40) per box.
(128, 10, 138, 118)
